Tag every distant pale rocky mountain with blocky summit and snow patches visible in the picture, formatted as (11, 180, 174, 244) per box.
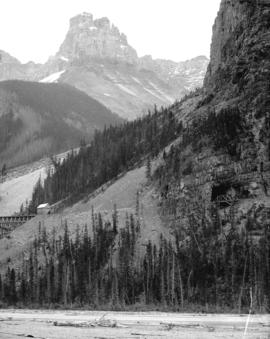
(0, 13, 208, 119)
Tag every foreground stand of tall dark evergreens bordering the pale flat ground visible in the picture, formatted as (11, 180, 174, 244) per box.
(0, 208, 270, 312)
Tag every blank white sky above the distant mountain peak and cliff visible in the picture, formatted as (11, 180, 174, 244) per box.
(0, 0, 221, 62)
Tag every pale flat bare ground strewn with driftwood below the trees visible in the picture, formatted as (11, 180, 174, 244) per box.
(0, 310, 270, 339)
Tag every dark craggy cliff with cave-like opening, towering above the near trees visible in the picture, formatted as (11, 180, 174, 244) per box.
(157, 0, 270, 231)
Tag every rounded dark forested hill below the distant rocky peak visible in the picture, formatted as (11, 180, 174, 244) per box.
(0, 80, 123, 166)
